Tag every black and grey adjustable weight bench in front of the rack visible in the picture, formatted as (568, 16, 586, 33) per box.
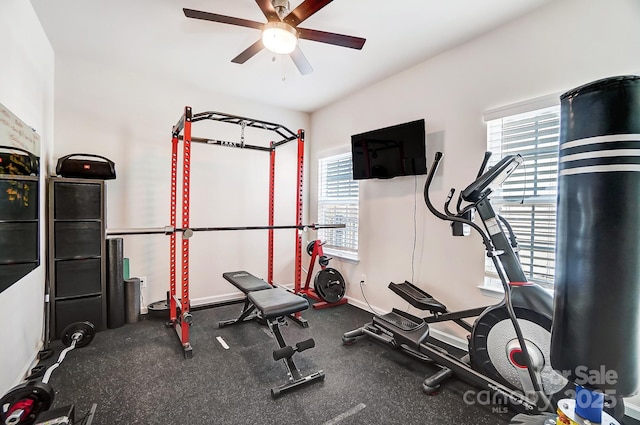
(218, 271, 324, 398)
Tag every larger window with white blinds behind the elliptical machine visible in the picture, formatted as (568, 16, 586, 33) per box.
(485, 106, 560, 286)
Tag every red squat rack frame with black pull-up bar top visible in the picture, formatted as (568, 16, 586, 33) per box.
(168, 106, 308, 358)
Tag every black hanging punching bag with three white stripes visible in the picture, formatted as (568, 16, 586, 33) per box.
(551, 76, 640, 397)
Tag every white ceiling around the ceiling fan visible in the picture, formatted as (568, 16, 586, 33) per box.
(31, 0, 551, 112)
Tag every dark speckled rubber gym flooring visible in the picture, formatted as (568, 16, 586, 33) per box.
(49, 304, 636, 425)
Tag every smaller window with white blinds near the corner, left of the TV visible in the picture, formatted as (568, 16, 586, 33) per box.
(318, 152, 359, 260)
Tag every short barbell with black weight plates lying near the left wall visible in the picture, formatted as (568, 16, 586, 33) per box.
(0, 322, 96, 425)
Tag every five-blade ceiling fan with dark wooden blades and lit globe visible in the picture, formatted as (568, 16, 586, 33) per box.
(182, 0, 366, 75)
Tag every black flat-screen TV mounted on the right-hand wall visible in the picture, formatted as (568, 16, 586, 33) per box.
(351, 119, 427, 180)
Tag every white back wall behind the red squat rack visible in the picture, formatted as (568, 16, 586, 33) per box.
(54, 55, 309, 308)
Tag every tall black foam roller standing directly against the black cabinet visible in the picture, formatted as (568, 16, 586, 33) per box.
(107, 238, 125, 329)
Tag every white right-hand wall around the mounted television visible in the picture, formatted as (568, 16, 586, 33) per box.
(310, 0, 640, 414)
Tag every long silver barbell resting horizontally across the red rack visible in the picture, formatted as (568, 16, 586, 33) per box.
(107, 223, 346, 239)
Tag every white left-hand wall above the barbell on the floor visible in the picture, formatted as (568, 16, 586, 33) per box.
(0, 0, 54, 394)
